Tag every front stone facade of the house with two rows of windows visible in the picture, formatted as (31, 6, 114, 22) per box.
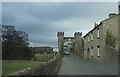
(84, 26, 104, 60)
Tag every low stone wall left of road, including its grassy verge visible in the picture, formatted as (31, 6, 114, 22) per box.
(2, 56, 62, 77)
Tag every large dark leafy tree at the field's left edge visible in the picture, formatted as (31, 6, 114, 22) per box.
(2, 25, 34, 60)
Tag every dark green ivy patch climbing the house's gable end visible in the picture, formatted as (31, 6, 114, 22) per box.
(105, 31, 116, 48)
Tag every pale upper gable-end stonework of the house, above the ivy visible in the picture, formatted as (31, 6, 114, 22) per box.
(102, 14, 120, 51)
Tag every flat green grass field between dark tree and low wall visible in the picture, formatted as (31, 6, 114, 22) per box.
(2, 60, 44, 75)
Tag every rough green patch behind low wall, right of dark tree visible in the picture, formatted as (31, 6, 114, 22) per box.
(35, 54, 54, 62)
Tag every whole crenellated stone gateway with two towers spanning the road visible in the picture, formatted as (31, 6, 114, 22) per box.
(57, 32, 83, 57)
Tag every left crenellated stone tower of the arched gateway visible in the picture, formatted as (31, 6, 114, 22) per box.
(57, 32, 64, 57)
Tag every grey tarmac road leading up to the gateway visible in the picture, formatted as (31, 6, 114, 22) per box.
(58, 54, 118, 75)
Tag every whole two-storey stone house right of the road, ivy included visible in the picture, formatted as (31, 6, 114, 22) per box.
(84, 6, 120, 64)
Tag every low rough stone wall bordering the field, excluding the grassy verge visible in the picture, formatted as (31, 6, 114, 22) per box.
(2, 56, 61, 77)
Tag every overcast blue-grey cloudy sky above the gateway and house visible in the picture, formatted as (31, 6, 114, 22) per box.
(2, 2, 118, 46)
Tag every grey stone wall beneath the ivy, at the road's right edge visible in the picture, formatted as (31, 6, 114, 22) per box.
(85, 46, 118, 65)
